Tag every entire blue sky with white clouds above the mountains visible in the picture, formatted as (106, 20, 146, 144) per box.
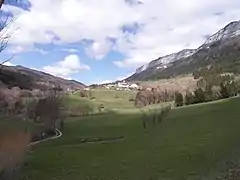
(0, 0, 240, 84)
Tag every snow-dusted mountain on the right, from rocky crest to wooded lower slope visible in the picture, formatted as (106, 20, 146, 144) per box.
(126, 21, 240, 81)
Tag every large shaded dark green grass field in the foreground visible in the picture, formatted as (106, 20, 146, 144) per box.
(20, 98, 240, 180)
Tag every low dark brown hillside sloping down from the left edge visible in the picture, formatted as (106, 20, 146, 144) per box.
(0, 66, 85, 90)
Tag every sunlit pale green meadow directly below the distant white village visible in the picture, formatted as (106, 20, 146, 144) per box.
(75, 89, 137, 109)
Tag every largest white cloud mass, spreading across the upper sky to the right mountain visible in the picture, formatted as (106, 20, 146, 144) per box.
(4, 0, 240, 68)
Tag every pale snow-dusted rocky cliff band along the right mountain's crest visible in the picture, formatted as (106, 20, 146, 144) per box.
(126, 21, 240, 80)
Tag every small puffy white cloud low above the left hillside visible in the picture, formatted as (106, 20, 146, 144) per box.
(42, 54, 90, 79)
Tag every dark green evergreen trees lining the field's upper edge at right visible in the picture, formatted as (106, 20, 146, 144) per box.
(175, 67, 240, 107)
